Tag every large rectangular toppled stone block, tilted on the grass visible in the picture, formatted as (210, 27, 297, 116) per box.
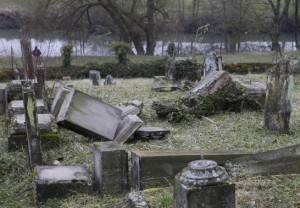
(55, 89, 122, 140)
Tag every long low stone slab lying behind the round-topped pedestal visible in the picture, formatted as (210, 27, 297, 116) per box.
(131, 151, 249, 190)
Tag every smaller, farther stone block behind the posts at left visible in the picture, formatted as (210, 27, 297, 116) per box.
(7, 99, 48, 118)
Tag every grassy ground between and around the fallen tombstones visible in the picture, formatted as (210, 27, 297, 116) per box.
(0, 74, 300, 208)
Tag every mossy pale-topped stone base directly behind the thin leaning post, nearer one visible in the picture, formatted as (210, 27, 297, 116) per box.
(8, 114, 60, 150)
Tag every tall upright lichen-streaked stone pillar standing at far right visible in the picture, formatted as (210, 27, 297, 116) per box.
(264, 59, 294, 133)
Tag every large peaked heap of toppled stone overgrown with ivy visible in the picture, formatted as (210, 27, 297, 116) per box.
(152, 71, 265, 121)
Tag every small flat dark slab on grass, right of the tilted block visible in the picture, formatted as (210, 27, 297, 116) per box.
(134, 126, 171, 140)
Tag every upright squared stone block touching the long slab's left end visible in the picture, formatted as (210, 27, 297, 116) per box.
(93, 142, 128, 195)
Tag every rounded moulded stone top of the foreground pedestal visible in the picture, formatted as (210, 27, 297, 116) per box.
(179, 160, 228, 186)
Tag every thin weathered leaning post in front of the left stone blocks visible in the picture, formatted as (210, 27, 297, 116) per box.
(23, 89, 43, 168)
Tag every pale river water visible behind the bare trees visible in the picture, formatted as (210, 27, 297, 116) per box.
(0, 30, 296, 57)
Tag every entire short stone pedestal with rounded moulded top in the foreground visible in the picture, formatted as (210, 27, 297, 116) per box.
(174, 160, 235, 208)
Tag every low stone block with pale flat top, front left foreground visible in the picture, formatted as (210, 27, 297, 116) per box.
(34, 166, 91, 202)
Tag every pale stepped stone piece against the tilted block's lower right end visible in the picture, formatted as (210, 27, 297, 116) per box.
(114, 115, 143, 143)
